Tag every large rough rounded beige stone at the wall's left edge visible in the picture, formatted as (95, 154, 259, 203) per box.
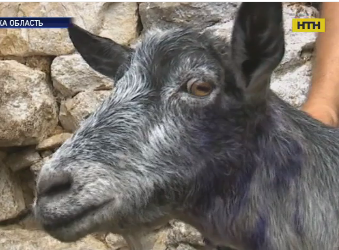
(0, 60, 58, 147)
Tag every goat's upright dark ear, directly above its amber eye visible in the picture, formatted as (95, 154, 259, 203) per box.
(231, 2, 285, 100)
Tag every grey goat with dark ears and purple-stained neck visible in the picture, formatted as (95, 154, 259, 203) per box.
(27, 3, 339, 250)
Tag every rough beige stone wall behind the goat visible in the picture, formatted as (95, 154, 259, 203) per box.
(0, 2, 318, 250)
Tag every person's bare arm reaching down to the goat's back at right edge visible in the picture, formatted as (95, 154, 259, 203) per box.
(302, 2, 339, 127)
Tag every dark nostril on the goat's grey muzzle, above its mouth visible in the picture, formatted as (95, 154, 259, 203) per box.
(38, 173, 72, 196)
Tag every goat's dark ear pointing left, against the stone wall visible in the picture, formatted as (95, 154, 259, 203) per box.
(68, 23, 133, 78)
